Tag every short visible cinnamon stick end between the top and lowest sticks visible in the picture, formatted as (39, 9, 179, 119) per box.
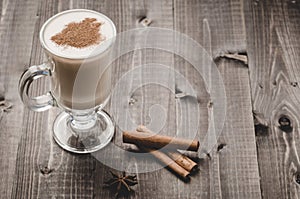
(167, 151, 198, 173)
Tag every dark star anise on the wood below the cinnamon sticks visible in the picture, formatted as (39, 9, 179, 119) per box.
(104, 171, 138, 198)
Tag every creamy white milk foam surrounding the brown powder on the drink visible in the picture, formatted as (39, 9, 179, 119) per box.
(40, 9, 116, 59)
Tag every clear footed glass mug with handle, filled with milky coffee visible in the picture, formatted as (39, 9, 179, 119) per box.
(19, 9, 116, 153)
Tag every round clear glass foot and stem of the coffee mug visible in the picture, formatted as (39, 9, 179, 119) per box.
(53, 110, 115, 153)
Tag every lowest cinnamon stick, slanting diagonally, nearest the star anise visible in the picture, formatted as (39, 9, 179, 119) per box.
(139, 146, 190, 179)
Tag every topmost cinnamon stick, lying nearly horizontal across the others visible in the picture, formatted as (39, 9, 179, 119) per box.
(123, 128, 199, 151)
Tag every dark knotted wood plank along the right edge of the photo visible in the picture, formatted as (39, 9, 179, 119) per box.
(245, 1, 300, 198)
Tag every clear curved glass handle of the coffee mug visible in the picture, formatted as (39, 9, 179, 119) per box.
(19, 63, 57, 112)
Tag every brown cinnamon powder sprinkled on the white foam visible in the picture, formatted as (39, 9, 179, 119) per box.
(51, 18, 104, 48)
